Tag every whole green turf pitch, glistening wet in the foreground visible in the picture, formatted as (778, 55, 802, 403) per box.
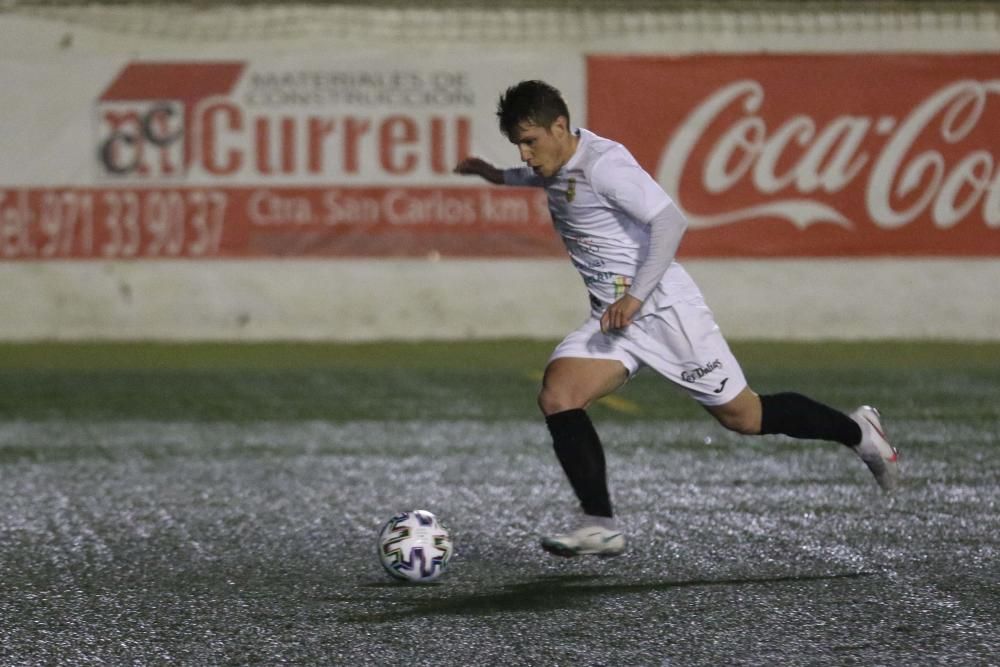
(0, 341, 1000, 666)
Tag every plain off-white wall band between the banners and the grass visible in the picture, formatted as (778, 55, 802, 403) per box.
(0, 259, 1000, 340)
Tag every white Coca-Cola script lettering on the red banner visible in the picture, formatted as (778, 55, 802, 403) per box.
(656, 78, 1000, 229)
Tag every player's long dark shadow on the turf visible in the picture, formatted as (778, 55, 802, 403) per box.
(340, 572, 872, 623)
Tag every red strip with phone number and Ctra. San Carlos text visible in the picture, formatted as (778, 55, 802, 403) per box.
(0, 187, 563, 260)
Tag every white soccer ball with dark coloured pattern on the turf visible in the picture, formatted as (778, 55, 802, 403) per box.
(378, 510, 454, 583)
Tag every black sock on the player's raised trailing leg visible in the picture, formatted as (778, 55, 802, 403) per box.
(760, 392, 861, 447)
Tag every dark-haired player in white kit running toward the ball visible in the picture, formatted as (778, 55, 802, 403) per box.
(455, 81, 898, 556)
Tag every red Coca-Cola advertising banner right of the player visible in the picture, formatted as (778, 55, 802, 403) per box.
(587, 54, 1000, 257)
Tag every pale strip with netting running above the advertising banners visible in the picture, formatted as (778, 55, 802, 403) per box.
(0, 0, 1000, 51)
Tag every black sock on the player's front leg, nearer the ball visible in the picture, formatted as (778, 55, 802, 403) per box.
(545, 409, 614, 517)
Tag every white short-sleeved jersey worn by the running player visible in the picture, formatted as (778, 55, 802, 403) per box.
(504, 128, 699, 314)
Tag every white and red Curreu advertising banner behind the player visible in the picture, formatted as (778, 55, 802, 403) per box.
(0, 53, 583, 260)
